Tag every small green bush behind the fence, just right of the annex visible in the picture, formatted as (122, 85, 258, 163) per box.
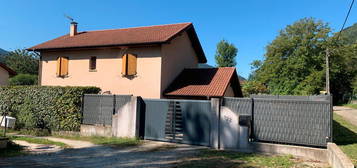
(242, 81, 268, 97)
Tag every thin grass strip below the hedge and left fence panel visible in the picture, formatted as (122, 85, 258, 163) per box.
(55, 135, 143, 147)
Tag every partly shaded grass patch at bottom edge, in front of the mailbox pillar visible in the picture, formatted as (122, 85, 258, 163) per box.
(177, 149, 298, 168)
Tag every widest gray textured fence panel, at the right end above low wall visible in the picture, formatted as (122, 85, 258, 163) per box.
(253, 99, 332, 146)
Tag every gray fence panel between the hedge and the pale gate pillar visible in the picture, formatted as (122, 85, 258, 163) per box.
(82, 94, 131, 125)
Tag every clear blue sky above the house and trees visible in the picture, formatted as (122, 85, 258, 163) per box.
(0, 0, 357, 77)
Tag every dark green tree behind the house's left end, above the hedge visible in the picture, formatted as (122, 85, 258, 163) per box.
(4, 49, 39, 75)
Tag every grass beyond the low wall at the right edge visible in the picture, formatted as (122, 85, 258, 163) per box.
(333, 113, 357, 167)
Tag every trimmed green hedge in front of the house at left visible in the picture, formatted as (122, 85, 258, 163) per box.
(0, 86, 100, 131)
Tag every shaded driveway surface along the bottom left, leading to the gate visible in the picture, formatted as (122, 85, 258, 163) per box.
(0, 142, 205, 168)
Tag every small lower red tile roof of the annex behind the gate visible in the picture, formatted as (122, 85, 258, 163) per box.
(164, 67, 241, 97)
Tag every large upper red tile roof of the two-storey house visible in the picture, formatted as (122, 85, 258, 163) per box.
(28, 23, 207, 62)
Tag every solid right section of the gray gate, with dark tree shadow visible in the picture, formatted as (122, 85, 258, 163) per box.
(176, 100, 213, 146)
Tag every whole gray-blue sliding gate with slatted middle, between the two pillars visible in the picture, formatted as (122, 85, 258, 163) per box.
(143, 99, 215, 146)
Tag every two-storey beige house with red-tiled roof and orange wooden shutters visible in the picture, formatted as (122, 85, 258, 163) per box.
(28, 22, 240, 98)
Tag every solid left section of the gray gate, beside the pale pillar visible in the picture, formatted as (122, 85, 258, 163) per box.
(144, 99, 170, 141)
